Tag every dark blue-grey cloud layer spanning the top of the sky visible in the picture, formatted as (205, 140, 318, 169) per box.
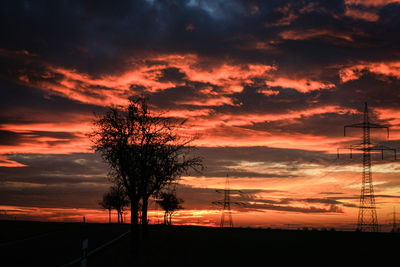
(1, 0, 400, 73)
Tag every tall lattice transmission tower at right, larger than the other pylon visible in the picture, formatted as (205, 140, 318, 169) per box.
(338, 103, 396, 232)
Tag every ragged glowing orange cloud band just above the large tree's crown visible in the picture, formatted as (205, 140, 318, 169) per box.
(19, 54, 276, 106)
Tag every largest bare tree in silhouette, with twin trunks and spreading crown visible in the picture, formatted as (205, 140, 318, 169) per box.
(90, 97, 202, 243)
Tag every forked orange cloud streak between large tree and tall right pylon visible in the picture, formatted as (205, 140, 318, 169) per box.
(178, 106, 357, 153)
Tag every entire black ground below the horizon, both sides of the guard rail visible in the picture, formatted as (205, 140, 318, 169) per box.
(0, 222, 400, 266)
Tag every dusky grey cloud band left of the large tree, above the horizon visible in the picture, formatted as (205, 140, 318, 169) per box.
(0, 154, 110, 209)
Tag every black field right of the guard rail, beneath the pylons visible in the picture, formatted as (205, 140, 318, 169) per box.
(89, 225, 400, 267)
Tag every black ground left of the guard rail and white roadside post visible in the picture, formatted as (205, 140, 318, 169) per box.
(0, 221, 129, 266)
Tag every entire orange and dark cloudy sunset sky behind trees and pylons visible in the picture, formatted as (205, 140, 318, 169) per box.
(0, 0, 400, 229)
